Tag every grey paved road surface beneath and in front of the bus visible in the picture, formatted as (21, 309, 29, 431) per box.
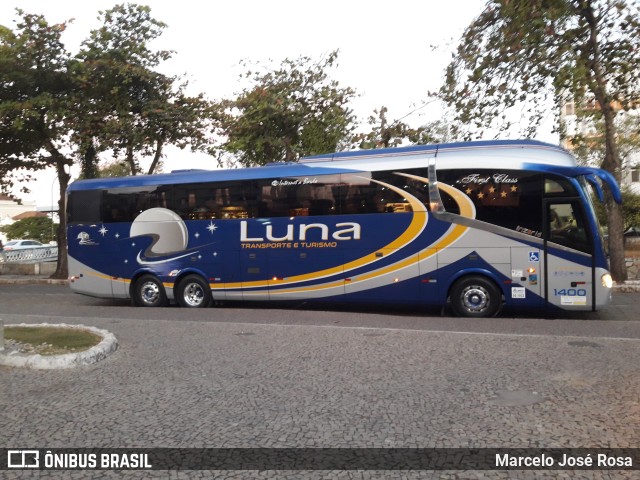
(0, 285, 640, 478)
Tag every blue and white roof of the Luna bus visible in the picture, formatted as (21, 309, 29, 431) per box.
(68, 140, 576, 191)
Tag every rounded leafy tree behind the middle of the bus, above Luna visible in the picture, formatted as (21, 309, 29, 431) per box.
(218, 51, 355, 166)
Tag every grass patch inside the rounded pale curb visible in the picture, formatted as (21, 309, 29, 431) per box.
(4, 327, 102, 355)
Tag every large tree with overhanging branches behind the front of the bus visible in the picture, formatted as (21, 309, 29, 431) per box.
(439, 0, 640, 281)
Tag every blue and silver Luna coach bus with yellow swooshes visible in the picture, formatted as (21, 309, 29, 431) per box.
(66, 140, 621, 317)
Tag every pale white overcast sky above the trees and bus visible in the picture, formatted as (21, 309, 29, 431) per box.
(0, 0, 552, 206)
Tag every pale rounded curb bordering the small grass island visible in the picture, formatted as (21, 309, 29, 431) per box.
(0, 323, 118, 370)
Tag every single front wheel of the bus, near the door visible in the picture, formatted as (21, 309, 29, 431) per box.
(450, 276, 502, 318)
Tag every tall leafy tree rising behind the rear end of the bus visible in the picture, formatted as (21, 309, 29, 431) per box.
(75, 4, 216, 178)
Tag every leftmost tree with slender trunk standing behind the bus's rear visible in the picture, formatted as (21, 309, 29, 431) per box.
(0, 10, 75, 278)
